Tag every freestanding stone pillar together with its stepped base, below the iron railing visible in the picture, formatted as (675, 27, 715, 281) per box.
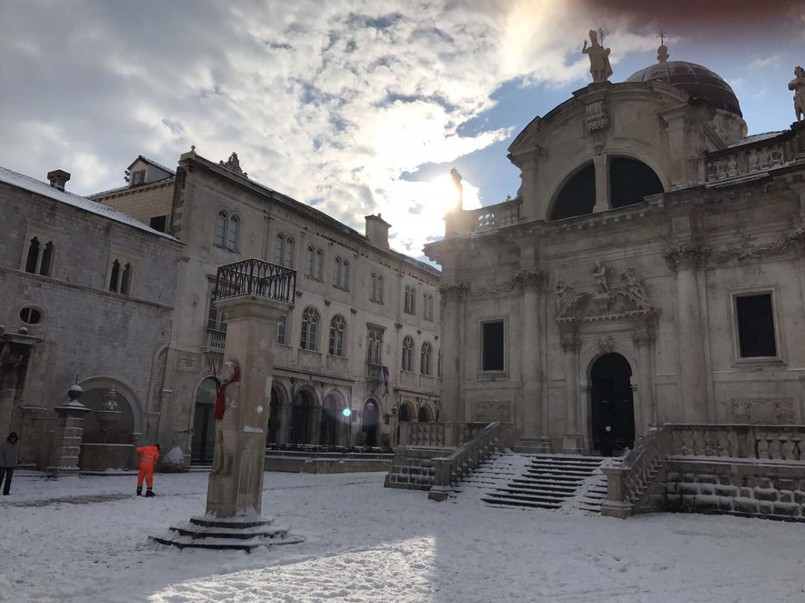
(154, 295, 302, 550)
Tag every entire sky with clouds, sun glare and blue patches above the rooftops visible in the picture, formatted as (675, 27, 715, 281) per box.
(0, 0, 805, 257)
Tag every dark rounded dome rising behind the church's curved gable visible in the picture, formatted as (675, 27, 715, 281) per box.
(626, 61, 743, 117)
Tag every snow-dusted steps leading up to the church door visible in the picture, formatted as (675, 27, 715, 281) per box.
(461, 452, 617, 513)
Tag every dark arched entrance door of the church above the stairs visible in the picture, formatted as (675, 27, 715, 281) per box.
(590, 353, 635, 456)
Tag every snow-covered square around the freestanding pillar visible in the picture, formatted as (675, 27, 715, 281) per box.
(0, 472, 805, 603)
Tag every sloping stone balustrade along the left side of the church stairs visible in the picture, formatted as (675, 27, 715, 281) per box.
(428, 422, 506, 501)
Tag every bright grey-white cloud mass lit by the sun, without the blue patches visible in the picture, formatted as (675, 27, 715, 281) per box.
(0, 0, 656, 255)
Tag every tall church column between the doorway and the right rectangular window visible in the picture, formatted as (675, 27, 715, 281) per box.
(665, 242, 708, 423)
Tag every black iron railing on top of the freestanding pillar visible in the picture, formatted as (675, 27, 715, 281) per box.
(213, 259, 296, 305)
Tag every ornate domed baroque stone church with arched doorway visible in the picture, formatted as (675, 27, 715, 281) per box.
(426, 46, 805, 451)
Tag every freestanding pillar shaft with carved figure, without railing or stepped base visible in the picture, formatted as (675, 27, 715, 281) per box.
(207, 295, 291, 519)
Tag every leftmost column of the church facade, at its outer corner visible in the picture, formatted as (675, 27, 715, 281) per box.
(441, 284, 467, 425)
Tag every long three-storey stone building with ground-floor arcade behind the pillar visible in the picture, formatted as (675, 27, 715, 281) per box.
(93, 151, 441, 463)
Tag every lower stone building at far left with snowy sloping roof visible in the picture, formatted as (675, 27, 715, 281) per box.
(0, 168, 181, 469)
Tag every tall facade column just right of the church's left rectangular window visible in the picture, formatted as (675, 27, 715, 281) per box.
(520, 271, 547, 451)
